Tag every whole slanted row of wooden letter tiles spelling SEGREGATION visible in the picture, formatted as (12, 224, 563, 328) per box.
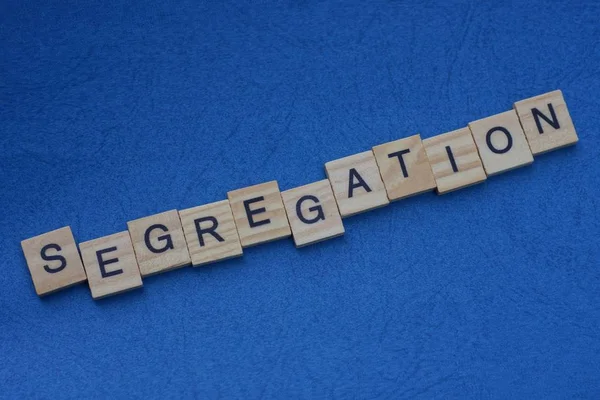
(21, 91, 577, 299)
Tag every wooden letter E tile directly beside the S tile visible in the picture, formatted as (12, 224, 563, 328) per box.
(79, 231, 142, 300)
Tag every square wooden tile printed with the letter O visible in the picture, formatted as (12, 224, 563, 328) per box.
(469, 110, 533, 176)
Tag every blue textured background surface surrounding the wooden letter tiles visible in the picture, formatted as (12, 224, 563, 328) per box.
(0, 1, 600, 399)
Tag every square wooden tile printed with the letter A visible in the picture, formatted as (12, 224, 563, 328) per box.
(325, 150, 390, 217)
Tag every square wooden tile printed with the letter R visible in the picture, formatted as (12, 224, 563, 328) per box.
(179, 200, 243, 267)
